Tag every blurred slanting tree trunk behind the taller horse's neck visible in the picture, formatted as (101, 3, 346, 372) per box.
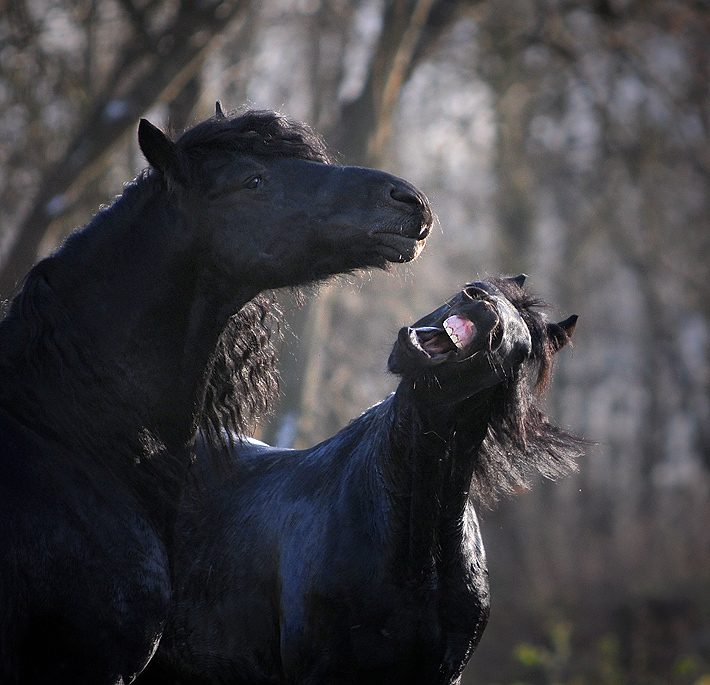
(0, 0, 251, 297)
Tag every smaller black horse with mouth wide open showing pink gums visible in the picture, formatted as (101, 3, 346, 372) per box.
(136, 277, 579, 685)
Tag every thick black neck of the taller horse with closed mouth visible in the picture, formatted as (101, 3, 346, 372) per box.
(0, 181, 253, 524)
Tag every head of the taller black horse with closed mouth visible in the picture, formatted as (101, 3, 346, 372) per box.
(139, 107, 432, 292)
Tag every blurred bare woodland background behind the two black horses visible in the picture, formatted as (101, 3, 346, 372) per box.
(0, 0, 710, 685)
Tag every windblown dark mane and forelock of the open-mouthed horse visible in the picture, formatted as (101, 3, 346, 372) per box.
(472, 278, 587, 505)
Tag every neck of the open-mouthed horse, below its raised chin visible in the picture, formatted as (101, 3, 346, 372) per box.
(381, 381, 496, 582)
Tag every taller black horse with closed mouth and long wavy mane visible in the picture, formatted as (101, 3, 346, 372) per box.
(0, 106, 431, 685)
